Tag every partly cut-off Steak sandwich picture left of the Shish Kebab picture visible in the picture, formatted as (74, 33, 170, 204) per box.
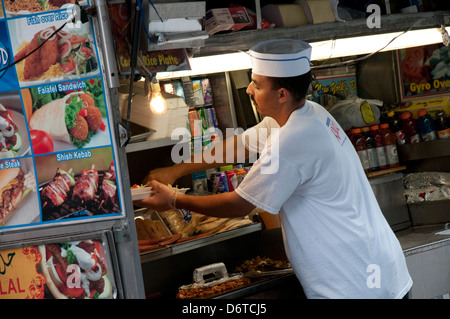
(0, 157, 40, 228)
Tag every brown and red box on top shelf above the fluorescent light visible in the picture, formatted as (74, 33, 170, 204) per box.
(205, 7, 250, 34)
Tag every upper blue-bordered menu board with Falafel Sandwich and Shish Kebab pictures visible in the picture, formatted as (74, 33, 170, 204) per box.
(0, 0, 123, 231)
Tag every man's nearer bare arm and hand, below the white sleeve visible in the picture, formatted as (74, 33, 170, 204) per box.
(133, 181, 255, 218)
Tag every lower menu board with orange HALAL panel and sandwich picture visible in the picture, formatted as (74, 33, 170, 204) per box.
(0, 238, 117, 299)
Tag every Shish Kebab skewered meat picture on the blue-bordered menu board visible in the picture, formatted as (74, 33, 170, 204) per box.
(35, 147, 121, 221)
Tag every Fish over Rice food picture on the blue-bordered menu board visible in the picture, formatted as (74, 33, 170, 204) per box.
(8, 11, 100, 87)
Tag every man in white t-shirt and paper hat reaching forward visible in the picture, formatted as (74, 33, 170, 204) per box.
(135, 40, 412, 298)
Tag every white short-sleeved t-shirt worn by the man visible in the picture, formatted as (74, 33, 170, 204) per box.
(236, 101, 412, 299)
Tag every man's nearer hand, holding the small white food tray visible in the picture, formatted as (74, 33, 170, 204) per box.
(133, 181, 177, 212)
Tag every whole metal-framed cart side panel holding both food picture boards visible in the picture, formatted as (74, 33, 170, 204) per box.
(0, 1, 143, 299)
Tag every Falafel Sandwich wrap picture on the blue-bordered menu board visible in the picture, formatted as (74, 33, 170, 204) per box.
(22, 78, 111, 154)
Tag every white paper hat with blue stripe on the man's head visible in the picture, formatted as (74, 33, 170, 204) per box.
(249, 39, 311, 78)
